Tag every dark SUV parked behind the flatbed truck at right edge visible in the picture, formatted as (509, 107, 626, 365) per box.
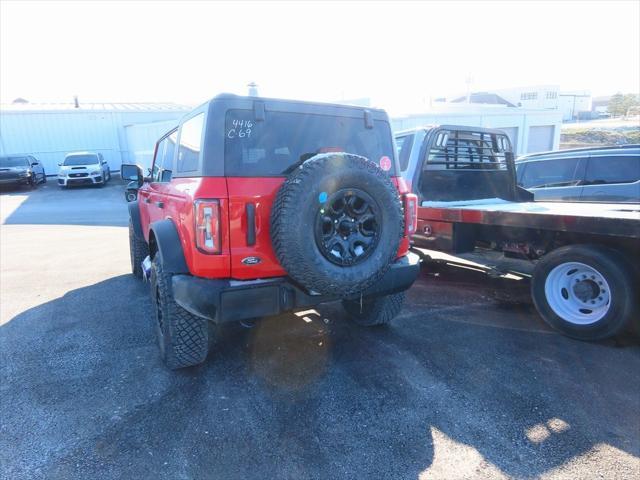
(516, 145, 640, 203)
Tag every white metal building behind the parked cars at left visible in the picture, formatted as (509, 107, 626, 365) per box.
(0, 103, 190, 175)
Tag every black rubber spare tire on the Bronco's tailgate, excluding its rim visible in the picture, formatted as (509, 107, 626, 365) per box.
(270, 153, 404, 298)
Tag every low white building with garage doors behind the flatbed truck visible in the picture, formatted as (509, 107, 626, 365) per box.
(392, 103, 562, 155)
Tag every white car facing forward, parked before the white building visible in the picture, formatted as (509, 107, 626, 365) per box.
(58, 152, 111, 188)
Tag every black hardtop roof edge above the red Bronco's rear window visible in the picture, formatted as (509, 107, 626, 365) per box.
(185, 93, 389, 121)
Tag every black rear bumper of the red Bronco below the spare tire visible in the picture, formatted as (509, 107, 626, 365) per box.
(172, 253, 420, 323)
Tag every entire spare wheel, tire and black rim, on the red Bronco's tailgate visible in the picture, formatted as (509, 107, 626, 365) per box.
(271, 153, 404, 297)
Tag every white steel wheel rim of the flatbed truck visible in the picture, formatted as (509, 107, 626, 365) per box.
(544, 262, 611, 325)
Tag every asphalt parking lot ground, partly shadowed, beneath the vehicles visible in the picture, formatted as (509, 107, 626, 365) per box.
(0, 180, 640, 479)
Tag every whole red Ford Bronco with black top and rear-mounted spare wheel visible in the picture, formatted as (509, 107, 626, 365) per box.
(122, 95, 419, 369)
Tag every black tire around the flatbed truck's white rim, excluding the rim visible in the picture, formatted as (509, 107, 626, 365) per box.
(531, 245, 639, 341)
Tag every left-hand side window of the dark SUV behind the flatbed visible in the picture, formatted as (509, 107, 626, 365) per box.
(520, 158, 584, 188)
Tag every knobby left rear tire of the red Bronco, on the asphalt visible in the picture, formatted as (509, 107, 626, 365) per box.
(151, 254, 209, 370)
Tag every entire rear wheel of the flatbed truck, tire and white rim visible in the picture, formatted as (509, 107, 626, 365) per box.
(531, 245, 638, 340)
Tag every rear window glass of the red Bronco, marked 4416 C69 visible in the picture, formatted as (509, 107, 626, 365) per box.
(224, 110, 394, 177)
